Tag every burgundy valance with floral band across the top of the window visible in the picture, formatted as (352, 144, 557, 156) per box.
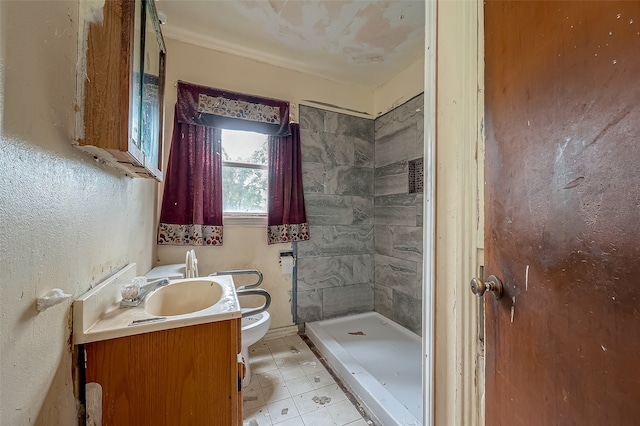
(176, 81, 291, 136)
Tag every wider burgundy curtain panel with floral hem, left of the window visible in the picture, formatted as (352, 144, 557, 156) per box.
(158, 108, 222, 246)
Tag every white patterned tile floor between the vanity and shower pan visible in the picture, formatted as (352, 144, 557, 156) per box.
(242, 335, 372, 426)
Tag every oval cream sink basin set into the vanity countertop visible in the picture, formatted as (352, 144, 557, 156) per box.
(144, 279, 223, 317)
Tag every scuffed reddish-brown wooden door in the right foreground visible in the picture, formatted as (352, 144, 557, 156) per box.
(485, 1, 640, 426)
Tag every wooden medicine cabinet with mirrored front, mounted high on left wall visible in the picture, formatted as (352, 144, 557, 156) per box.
(77, 0, 166, 180)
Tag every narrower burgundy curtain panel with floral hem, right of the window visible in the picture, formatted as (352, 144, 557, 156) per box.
(267, 123, 309, 244)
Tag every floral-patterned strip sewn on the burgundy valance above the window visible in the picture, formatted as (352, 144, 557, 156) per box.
(198, 93, 280, 124)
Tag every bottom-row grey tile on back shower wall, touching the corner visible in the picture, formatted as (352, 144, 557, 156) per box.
(322, 284, 373, 319)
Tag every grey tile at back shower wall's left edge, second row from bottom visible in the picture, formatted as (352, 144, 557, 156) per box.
(298, 256, 360, 291)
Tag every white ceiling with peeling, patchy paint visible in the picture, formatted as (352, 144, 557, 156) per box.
(156, 0, 425, 88)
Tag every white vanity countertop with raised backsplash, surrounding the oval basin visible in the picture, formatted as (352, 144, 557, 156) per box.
(73, 264, 242, 345)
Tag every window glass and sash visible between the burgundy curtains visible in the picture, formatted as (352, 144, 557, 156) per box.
(222, 130, 269, 217)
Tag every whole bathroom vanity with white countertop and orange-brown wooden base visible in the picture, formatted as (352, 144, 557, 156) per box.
(73, 264, 243, 426)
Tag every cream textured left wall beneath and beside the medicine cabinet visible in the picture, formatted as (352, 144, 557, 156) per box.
(0, 1, 157, 426)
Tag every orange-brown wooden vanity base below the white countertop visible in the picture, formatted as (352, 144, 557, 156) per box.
(85, 319, 242, 426)
